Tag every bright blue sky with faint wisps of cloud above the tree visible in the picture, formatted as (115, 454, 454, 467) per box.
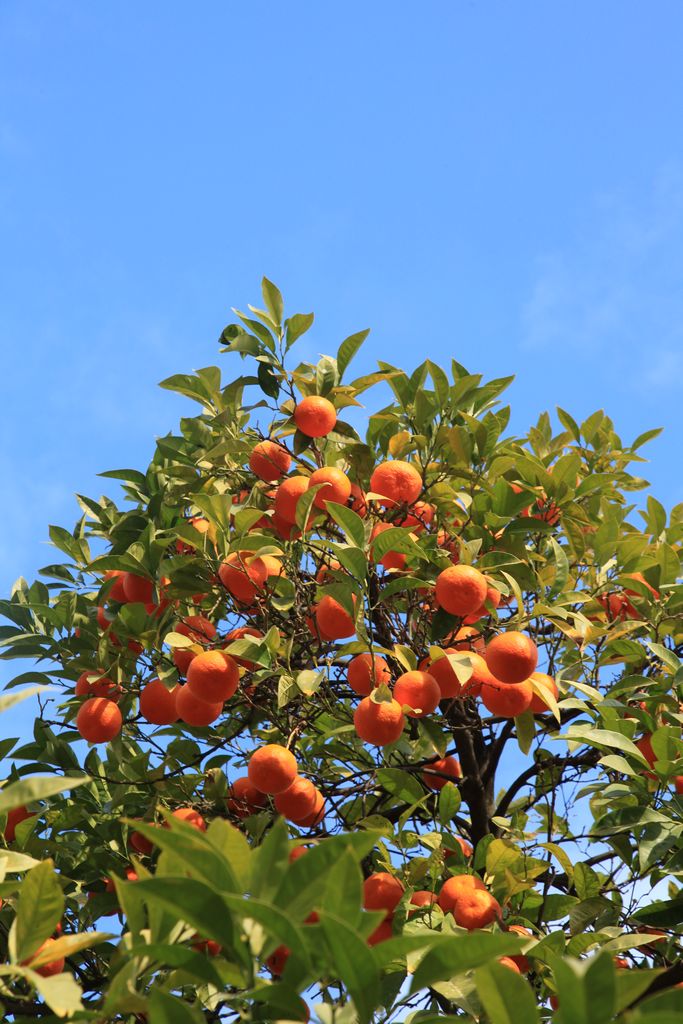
(0, 0, 683, 729)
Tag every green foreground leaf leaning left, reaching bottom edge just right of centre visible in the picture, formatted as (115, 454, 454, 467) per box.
(319, 913, 380, 1024)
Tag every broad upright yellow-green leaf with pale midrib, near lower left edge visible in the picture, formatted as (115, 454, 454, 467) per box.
(9, 860, 65, 963)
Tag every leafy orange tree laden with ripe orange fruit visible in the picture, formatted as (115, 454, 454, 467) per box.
(0, 281, 683, 1024)
